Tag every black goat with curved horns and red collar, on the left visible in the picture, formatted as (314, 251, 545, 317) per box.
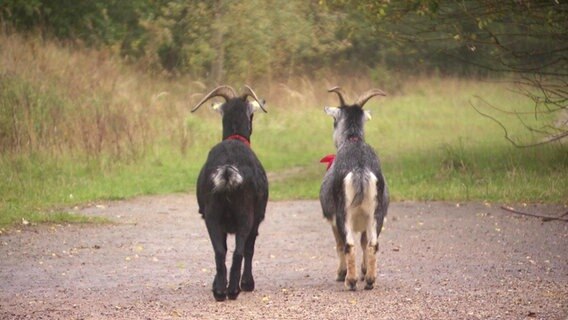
(191, 86, 268, 301)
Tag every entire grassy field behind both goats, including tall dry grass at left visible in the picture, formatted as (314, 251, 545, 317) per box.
(0, 34, 568, 225)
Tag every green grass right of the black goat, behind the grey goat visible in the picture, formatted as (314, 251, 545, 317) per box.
(258, 79, 568, 203)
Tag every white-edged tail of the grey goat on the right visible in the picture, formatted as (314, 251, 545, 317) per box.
(343, 170, 378, 207)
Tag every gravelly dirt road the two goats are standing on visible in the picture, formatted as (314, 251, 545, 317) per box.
(0, 195, 568, 320)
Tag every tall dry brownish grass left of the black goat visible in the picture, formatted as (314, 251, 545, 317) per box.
(0, 35, 211, 159)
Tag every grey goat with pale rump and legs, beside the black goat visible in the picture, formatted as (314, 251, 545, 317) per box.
(320, 87, 389, 290)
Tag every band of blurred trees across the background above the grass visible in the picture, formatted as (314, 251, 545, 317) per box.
(0, 0, 568, 143)
